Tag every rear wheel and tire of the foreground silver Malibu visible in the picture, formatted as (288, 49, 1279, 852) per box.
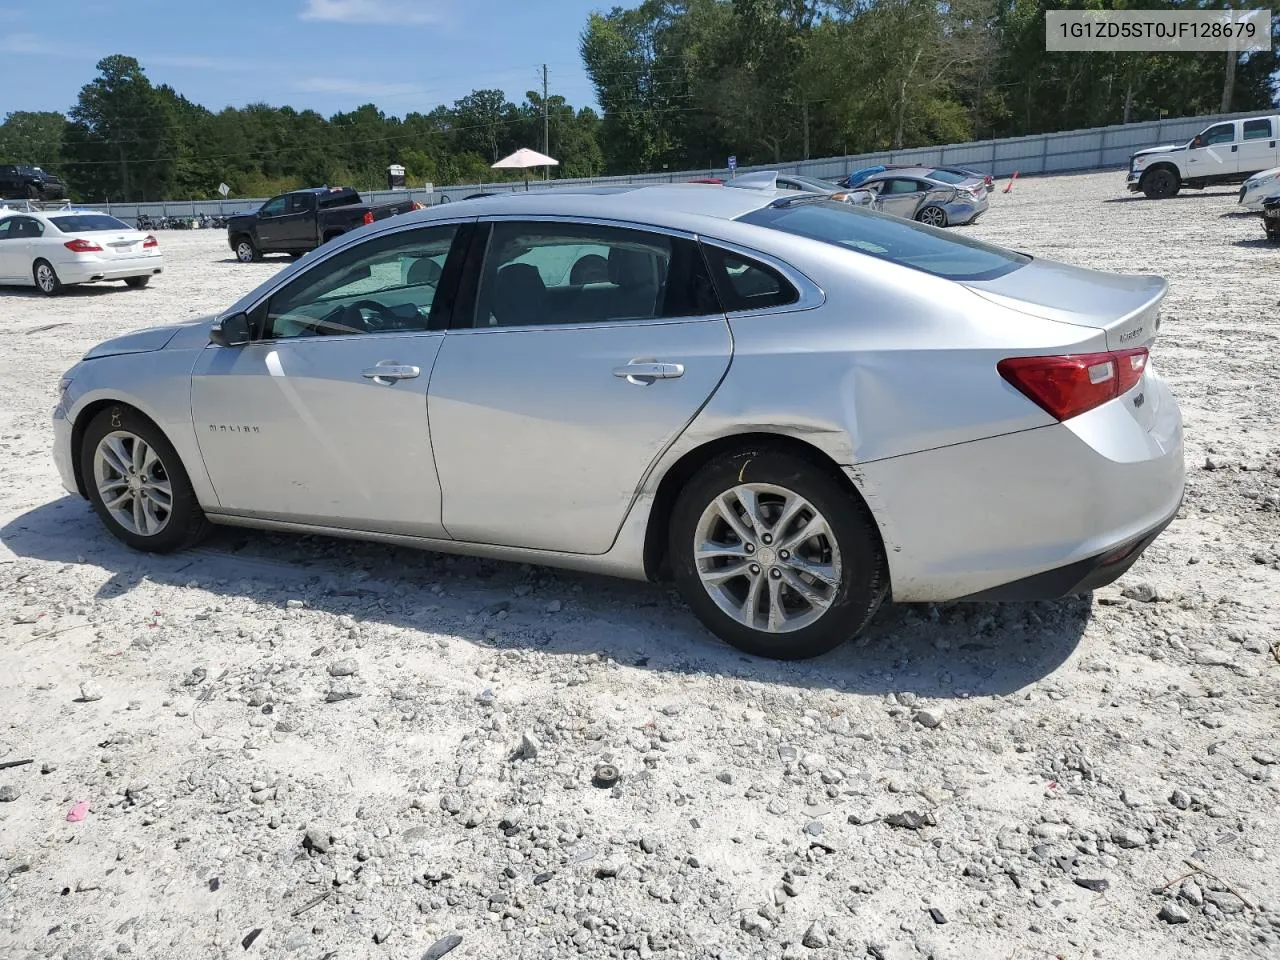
(667, 448, 888, 660)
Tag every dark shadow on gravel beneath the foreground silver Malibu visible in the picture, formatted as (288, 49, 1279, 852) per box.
(0, 497, 1092, 698)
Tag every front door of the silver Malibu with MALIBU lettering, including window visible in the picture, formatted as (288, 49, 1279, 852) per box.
(191, 224, 466, 536)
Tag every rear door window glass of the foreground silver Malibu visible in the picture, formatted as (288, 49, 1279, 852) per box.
(472, 221, 719, 328)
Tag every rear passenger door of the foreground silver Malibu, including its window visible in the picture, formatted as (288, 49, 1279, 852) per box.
(428, 218, 732, 554)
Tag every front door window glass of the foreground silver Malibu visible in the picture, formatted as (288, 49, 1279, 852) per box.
(262, 224, 457, 339)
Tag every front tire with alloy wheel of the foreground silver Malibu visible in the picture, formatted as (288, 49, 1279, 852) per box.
(79, 404, 210, 553)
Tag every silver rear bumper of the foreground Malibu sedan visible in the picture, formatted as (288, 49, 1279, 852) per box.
(847, 367, 1185, 603)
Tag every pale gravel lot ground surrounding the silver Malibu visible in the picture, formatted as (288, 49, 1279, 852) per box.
(0, 172, 1280, 960)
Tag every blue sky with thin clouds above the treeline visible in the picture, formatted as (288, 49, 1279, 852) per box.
(0, 0, 604, 119)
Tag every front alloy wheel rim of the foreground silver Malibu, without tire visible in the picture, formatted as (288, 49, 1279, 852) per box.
(93, 430, 173, 536)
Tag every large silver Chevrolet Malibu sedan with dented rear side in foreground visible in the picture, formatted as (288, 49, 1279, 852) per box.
(54, 184, 1183, 658)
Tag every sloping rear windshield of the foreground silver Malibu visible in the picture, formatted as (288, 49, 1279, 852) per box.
(739, 200, 1030, 280)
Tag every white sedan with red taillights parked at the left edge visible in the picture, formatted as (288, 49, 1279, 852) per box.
(0, 206, 164, 296)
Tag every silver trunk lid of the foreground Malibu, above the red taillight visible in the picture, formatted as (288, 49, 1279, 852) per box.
(964, 260, 1169, 349)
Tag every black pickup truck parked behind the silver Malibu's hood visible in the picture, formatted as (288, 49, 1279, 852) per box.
(227, 187, 422, 264)
